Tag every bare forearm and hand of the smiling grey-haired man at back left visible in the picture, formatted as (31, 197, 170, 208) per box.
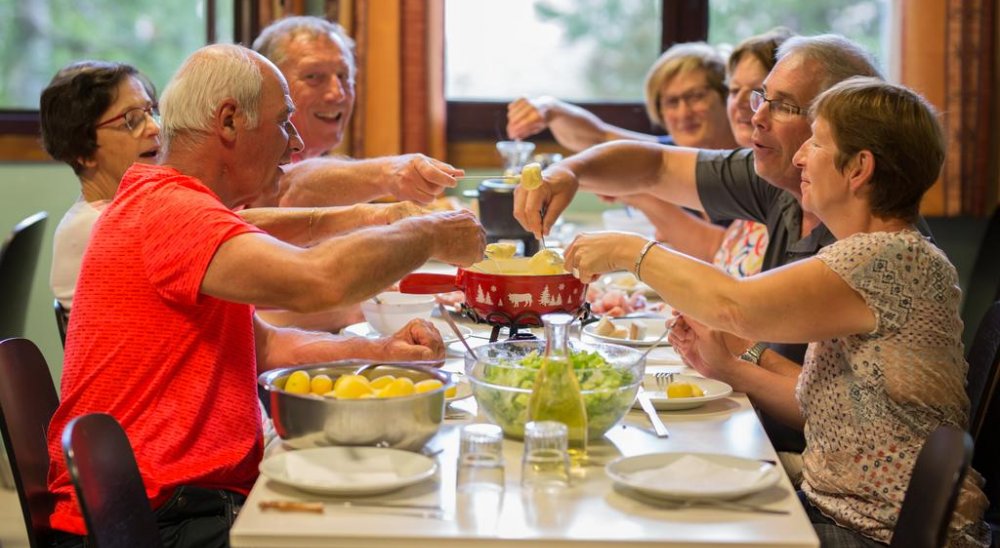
(270, 154, 465, 207)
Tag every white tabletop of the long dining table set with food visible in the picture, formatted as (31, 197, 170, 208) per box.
(230, 265, 819, 548)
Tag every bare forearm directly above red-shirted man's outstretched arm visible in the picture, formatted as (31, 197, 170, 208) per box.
(240, 204, 387, 246)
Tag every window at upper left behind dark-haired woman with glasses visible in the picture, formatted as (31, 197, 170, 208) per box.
(0, 0, 234, 134)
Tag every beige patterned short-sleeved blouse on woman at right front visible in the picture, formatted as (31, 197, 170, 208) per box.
(796, 230, 988, 546)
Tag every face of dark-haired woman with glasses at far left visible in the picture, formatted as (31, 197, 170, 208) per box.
(83, 77, 160, 182)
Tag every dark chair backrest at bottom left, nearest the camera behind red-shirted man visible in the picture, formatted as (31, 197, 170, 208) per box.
(62, 413, 163, 548)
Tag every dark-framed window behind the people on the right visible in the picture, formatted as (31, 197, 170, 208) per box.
(445, 0, 897, 141)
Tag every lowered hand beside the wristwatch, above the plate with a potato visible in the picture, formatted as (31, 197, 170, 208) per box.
(667, 314, 742, 390)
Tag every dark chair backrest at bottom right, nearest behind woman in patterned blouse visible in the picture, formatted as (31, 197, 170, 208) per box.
(890, 425, 972, 548)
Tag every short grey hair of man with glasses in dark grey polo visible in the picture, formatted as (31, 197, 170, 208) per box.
(778, 34, 885, 92)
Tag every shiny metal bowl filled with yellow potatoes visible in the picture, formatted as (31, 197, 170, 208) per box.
(257, 360, 451, 451)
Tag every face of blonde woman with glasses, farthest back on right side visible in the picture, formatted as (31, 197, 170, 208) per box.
(658, 70, 732, 148)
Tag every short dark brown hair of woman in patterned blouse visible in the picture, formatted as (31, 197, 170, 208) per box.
(810, 76, 945, 223)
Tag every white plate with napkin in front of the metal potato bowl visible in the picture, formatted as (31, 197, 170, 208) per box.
(260, 447, 437, 495)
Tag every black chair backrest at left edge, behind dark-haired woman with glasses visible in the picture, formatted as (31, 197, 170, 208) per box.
(0, 211, 48, 339)
